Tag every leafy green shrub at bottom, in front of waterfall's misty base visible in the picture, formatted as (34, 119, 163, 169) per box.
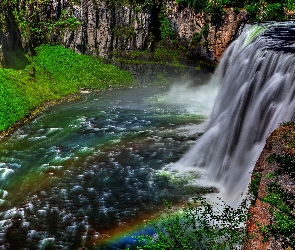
(138, 197, 248, 250)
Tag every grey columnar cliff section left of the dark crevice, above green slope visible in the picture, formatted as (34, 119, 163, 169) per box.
(59, 0, 154, 58)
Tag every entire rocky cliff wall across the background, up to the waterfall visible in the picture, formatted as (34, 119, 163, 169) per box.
(0, 0, 247, 67)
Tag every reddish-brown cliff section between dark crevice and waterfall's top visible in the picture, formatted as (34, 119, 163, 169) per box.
(166, 1, 248, 62)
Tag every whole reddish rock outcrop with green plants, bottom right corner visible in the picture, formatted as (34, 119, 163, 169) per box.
(242, 125, 295, 250)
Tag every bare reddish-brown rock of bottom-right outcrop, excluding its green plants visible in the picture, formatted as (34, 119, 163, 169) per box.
(242, 125, 295, 250)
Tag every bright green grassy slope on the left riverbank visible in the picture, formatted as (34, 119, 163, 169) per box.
(0, 45, 134, 131)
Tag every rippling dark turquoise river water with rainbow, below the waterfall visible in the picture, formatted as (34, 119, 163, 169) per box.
(0, 87, 215, 249)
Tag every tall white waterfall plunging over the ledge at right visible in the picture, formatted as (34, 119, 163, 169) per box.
(174, 22, 295, 203)
